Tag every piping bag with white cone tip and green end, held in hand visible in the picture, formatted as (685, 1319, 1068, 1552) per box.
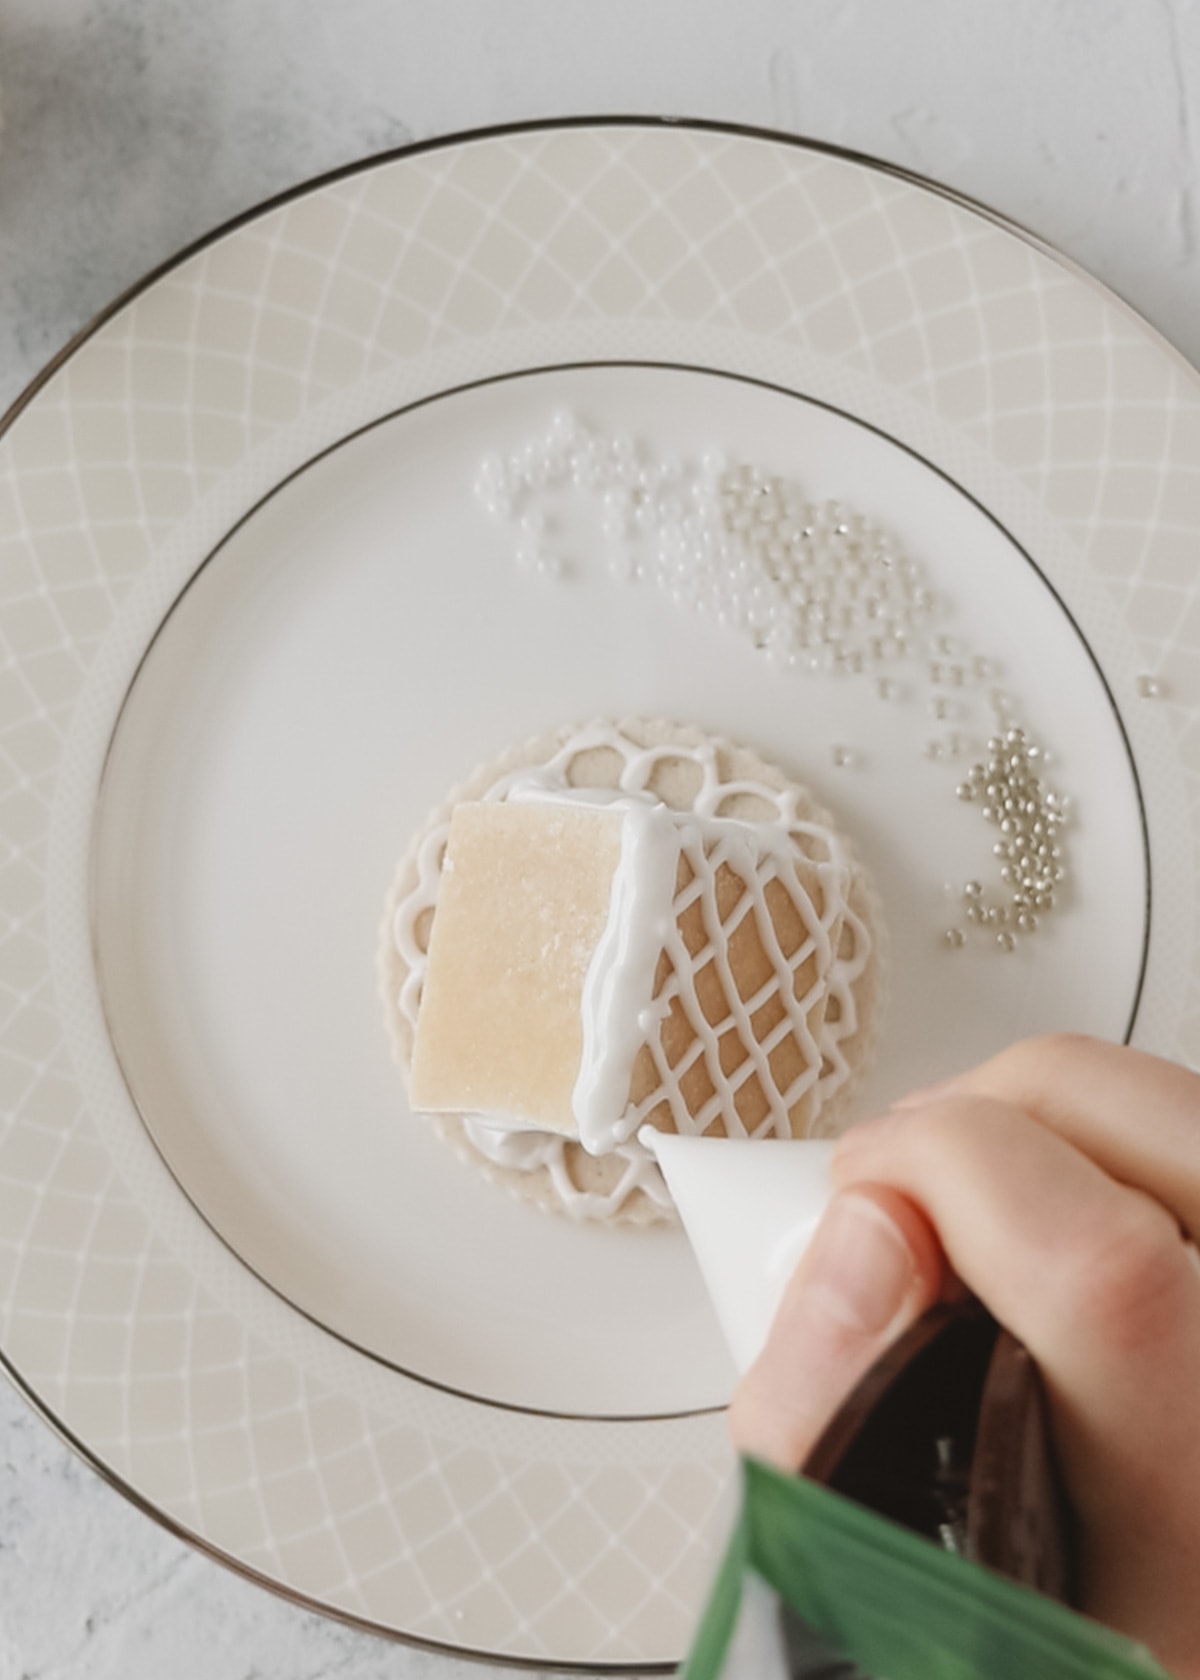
(639, 1127, 1165, 1680)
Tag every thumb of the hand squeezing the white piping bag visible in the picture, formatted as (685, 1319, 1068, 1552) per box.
(729, 1184, 945, 1470)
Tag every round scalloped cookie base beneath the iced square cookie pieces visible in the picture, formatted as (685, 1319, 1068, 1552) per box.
(378, 719, 884, 1225)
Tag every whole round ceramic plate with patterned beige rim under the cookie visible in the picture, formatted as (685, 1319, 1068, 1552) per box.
(0, 123, 1200, 1665)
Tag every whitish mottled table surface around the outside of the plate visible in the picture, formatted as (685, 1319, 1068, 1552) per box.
(0, 0, 1200, 1680)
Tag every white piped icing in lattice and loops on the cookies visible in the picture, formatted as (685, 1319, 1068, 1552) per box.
(393, 724, 871, 1220)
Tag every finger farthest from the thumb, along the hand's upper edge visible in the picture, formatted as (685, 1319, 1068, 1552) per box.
(880, 1033, 1200, 1238)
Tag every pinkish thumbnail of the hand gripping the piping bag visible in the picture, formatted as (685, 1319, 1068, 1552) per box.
(802, 1193, 916, 1336)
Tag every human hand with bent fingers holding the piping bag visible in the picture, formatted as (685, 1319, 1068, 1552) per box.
(729, 1037, 1200, 1680)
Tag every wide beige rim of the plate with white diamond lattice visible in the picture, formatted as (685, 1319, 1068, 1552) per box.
(0, 126, 1200, 1662)
